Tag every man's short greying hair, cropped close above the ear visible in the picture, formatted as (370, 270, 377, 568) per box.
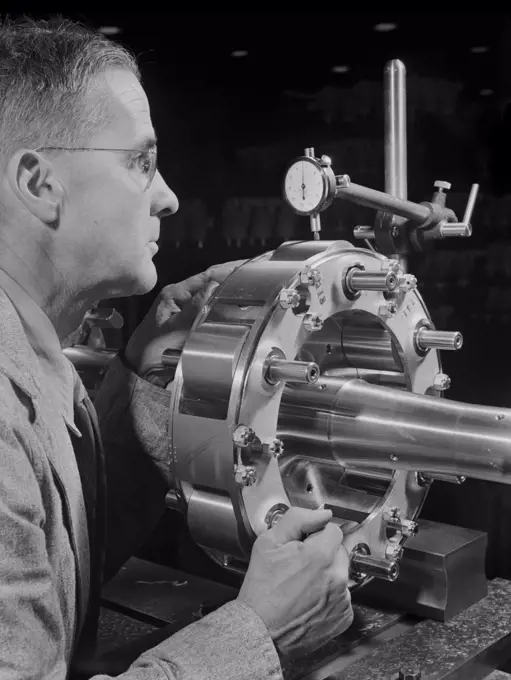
(0, 16, 140, 161)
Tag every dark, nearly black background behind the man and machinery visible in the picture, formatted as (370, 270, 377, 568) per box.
(8, 6, 511, 578)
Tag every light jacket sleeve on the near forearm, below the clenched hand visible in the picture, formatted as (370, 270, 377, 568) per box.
(146, 600, 283, 680)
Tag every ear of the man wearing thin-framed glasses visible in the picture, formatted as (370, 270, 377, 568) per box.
(7, 149, 64, 225)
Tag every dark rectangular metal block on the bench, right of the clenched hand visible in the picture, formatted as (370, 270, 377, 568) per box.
(354, 520, 488, 621)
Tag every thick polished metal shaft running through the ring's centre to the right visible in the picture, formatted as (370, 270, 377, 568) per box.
(278, 377, 511, 484)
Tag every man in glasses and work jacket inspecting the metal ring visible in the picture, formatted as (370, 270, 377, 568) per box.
(0, 15, 352, 680)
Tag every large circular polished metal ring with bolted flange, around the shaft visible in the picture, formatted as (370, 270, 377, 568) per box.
(170, 241, 441, 586)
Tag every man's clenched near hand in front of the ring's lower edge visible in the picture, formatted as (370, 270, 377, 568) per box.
(238, 508, 353, 656)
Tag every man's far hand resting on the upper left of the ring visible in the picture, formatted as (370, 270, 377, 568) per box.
(124, 260, 245, 377)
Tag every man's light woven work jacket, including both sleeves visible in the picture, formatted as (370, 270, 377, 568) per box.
(0, 277, 282, 680)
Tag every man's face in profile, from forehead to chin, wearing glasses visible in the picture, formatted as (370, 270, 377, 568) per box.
(55, 70, 178, 297)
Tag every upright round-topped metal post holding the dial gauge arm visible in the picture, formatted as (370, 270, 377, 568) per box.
(384, 59, 408, 271)
